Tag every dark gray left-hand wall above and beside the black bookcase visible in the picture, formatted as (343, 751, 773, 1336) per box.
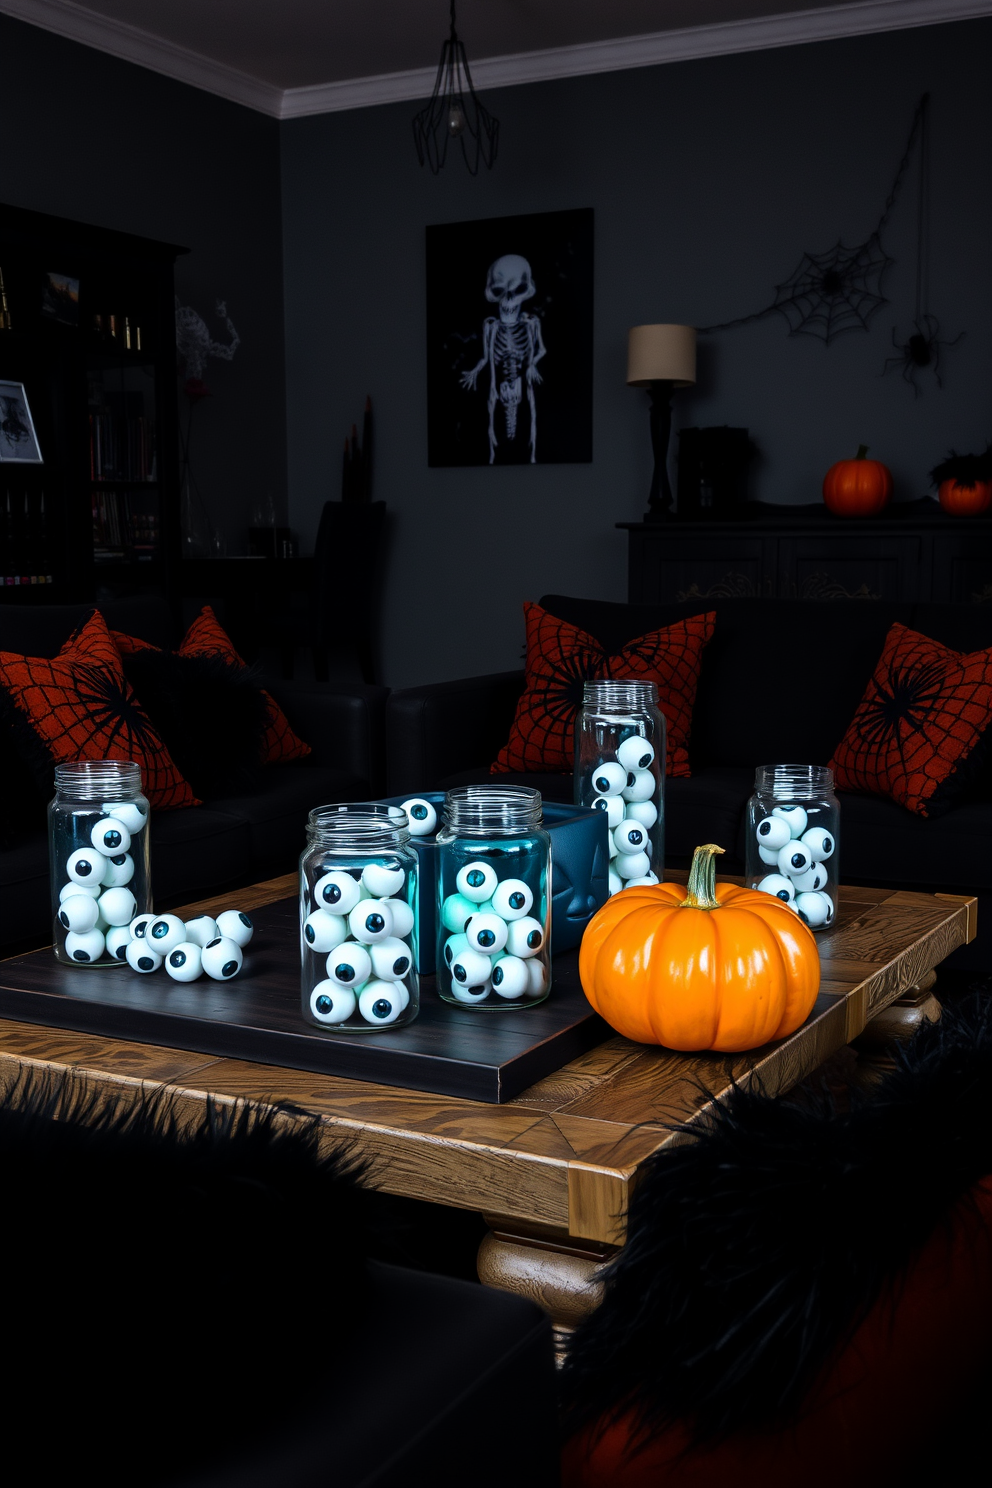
(0, 16, 286, 552)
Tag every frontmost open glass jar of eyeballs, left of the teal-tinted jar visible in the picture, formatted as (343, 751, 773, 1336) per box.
(299, 802, 421, 1033)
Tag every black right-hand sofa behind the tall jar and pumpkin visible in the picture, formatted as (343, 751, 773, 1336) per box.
(387, 595, 992, 969)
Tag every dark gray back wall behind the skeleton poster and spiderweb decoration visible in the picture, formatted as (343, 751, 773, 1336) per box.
(283, 21, 992, 686)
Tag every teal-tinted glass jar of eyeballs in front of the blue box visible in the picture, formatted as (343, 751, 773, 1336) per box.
(436, 786, 552, 1012)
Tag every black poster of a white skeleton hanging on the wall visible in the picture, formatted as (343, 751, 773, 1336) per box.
(427, 208, 593, 466)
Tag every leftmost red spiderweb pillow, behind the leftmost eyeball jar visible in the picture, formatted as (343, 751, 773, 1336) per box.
(0, 610, 199, 811)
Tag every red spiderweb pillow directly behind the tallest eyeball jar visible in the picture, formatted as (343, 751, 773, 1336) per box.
(491, 604, 715, 775)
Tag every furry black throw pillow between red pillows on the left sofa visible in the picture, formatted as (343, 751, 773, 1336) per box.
(122, 647, 268, 801)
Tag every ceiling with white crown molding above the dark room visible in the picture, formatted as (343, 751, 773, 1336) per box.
(0, 0, 992, 116)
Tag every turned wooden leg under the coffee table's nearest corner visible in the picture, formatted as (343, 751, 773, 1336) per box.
(477, 1214, 616, 1363)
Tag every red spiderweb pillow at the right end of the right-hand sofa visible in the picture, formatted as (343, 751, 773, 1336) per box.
(830, 623, 992, 817)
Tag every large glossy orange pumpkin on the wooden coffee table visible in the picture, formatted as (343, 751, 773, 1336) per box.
(579, 842, 819, 1054)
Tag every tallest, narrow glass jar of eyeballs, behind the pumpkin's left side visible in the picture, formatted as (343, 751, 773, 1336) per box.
(576, 680, 665, 894)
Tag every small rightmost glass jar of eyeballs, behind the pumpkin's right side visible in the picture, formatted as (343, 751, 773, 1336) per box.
(744, 765, 840, 930)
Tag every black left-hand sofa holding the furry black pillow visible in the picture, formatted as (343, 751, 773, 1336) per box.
(0, 597, 387, 954)
